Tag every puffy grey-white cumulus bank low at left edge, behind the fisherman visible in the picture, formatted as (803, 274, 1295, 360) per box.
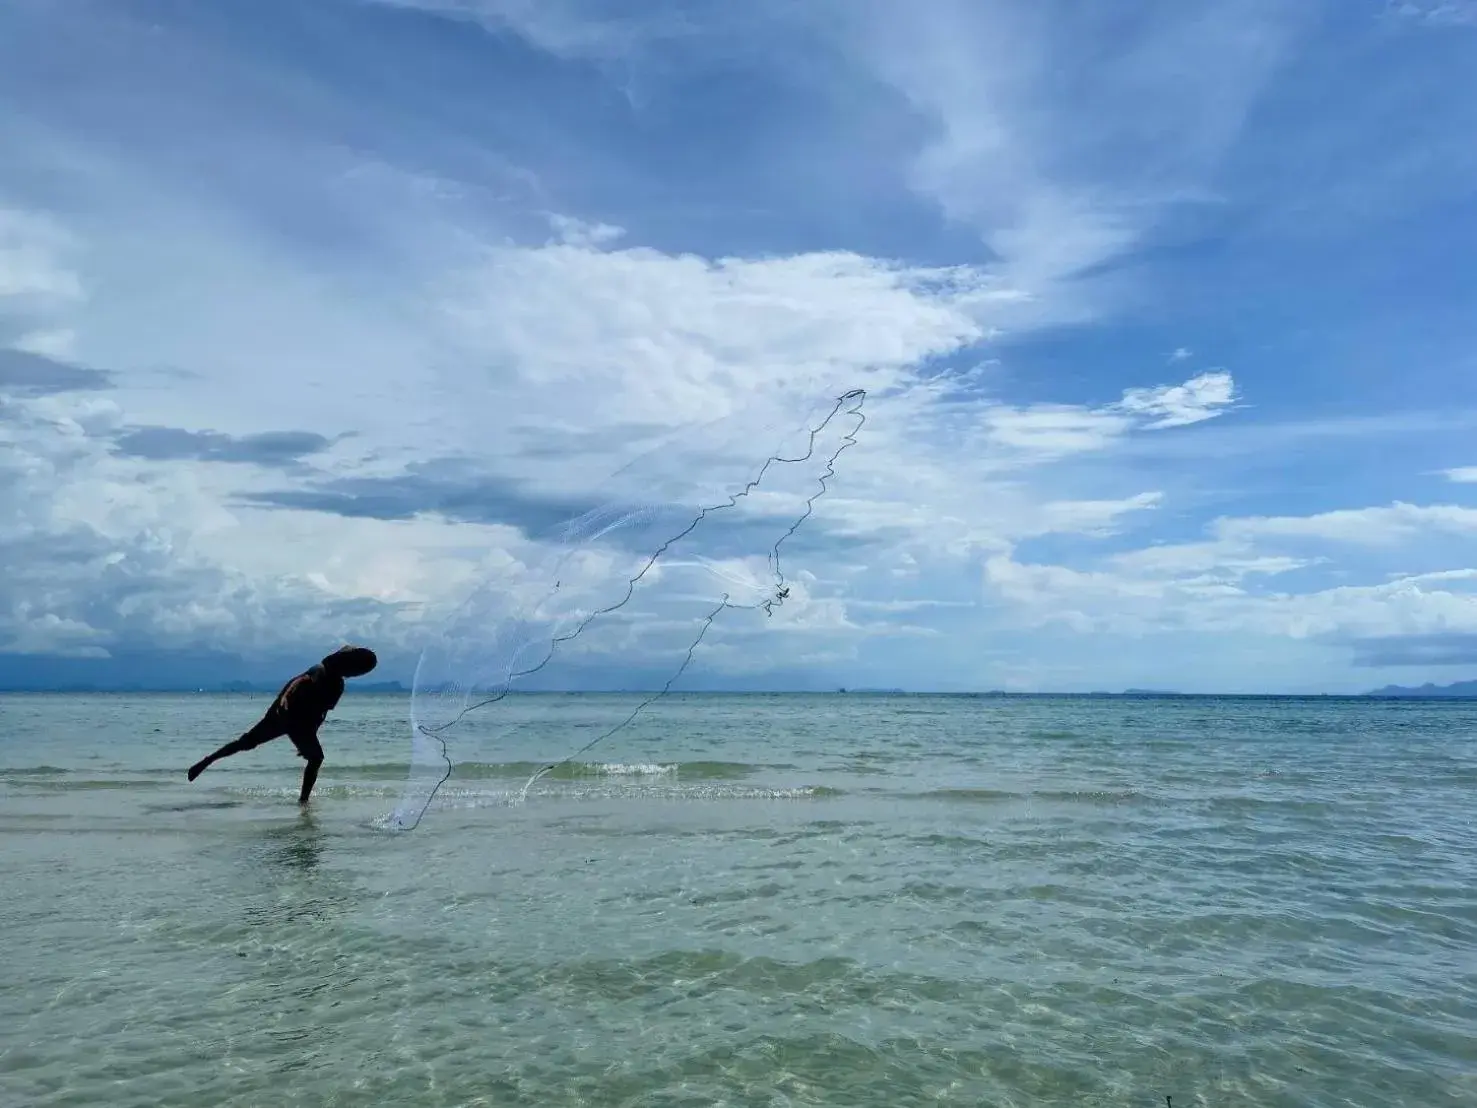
(0, 387, 404, 656)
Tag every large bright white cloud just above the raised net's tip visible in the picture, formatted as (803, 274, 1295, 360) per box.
(442, 245, 991, 430)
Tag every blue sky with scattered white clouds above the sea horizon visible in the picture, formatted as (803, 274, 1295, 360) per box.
(0, 0, 1477, 693)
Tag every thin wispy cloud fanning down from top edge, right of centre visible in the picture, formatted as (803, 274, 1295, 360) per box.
(826, 0, 1294, 301)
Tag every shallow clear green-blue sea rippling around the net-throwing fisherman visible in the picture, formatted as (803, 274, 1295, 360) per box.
(0, 694, 1477, 1108)
